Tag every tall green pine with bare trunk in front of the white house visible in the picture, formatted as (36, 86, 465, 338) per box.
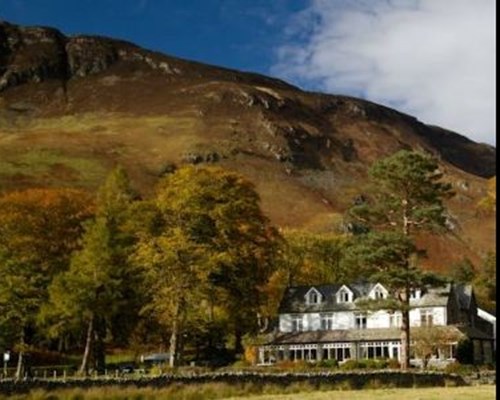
(349, 150, 452, 369)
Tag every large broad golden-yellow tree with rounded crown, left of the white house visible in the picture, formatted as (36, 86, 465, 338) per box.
(133, 166, 278, 362)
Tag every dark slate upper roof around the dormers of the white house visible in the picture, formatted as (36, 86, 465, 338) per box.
(278, 282, 458, 314)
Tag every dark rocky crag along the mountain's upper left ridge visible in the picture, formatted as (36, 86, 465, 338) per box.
(0, 21, 292, 92)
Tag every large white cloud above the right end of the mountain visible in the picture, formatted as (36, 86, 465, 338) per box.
(271, 0, 496, 145)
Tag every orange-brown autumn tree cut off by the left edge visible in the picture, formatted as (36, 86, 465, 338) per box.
(0, 189, 93, 378)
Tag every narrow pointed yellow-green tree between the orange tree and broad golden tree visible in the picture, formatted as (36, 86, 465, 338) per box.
(41, 168, 135, 374)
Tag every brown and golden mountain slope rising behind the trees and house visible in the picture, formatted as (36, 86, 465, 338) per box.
(0, 22, 496, 269)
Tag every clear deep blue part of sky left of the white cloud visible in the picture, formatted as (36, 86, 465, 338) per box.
(0, 0, 308, 74)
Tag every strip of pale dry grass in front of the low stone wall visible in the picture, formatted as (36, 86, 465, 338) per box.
(0, 383, 496, 400)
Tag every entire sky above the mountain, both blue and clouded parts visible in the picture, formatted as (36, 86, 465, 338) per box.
(0, 0, 496, 145)
